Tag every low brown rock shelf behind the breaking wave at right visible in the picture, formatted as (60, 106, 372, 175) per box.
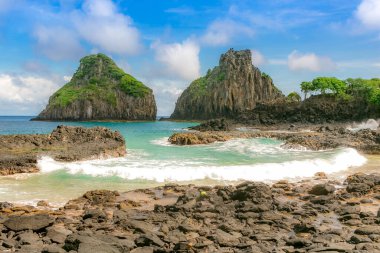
(169, 122, 380, 154)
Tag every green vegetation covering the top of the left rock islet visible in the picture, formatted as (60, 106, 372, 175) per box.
(49, 54, 151, 106)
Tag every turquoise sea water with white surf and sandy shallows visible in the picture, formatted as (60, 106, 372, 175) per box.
(0, 117, 366, 206)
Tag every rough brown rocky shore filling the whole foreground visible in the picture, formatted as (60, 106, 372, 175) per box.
(0, 173, 380, 253)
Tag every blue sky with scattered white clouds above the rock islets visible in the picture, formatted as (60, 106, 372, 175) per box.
(0, 0, 380, 115)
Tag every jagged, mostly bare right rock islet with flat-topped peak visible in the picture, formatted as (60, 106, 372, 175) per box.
(171, 49, 283, 119)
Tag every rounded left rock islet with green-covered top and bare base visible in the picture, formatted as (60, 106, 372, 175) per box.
(35, 54, 157, 120)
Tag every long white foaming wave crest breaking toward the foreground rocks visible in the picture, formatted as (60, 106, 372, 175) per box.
(38, 149, 366, 182)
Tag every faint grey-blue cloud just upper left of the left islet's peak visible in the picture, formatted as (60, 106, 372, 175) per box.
(34, 26, 84, 60)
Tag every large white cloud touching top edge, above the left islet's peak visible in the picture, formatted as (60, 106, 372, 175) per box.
(73, 0, 142, 54)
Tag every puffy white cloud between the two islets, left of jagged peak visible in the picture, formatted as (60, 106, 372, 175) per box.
(151, 39, 200, 80)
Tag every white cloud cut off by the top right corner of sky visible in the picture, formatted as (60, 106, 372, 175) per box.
(355, 0, 380, 29)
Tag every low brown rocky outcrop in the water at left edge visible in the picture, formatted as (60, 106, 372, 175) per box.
(0, 126, 126, 175)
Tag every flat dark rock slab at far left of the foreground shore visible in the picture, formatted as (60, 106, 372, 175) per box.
(4, 214, 54, 231)
